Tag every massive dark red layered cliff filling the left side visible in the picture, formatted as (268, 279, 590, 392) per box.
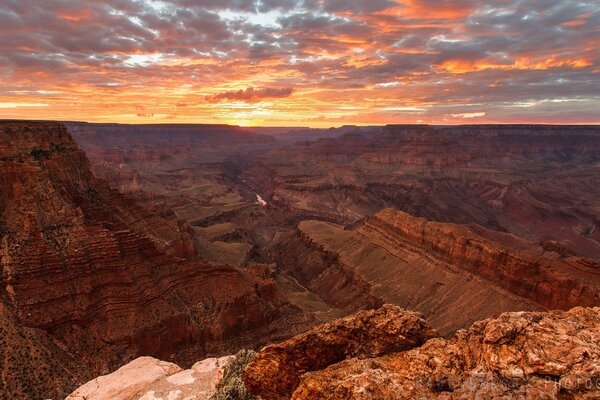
(0, 122, 308, 398)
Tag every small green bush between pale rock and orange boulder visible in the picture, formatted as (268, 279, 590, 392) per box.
(210, 350, 260, 400)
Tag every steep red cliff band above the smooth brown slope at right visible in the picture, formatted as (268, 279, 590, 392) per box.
(365, 209, 600, 309)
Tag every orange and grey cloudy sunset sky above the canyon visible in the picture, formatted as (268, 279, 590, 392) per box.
(0, 0, 600, 127)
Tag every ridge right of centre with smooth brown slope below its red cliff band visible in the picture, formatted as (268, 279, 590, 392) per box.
(288, 209, 600, 335)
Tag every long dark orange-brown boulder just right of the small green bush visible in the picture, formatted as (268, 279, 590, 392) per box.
(243, 305, 435, 399)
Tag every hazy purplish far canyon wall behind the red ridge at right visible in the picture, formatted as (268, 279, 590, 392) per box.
(242, 125, 600, 259)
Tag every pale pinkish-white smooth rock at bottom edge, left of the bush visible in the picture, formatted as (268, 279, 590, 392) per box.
(66, 356, 231, 400)
